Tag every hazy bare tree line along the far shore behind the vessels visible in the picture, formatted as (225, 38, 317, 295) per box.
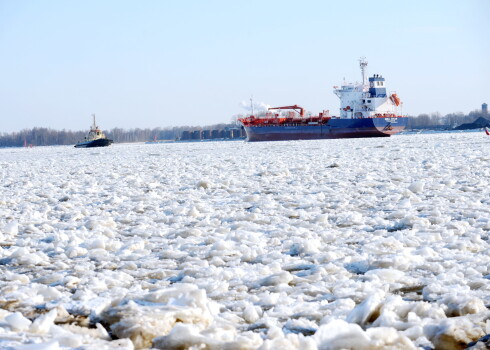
(0, 110, 489, 147)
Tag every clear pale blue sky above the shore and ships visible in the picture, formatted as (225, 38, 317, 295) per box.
(0, 0, 490, 132)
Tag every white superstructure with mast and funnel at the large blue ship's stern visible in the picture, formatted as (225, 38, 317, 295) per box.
(334, 58, 401, 119)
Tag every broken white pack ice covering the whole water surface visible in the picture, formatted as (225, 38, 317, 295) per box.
(0, 132, 490, 350)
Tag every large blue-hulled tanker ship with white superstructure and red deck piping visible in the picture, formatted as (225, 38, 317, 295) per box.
(238, 58, 408, 142)
